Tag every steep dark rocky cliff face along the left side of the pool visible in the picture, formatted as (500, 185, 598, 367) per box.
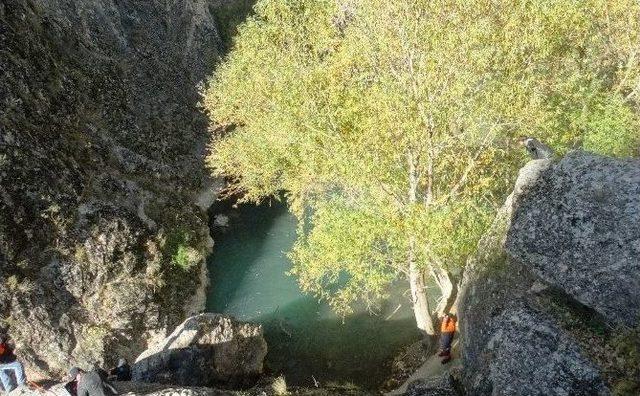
(0, 0, 230, 378)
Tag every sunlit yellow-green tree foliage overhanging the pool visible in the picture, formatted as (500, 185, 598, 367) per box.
(204, 0, 640, 313)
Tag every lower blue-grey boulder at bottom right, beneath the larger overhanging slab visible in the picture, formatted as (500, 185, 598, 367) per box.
(471, 304, 608, 396)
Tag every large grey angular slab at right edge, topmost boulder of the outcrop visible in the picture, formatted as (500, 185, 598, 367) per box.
(506, 152, 640, 326)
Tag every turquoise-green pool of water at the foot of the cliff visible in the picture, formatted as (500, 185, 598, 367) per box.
(207, 202, 419, 389)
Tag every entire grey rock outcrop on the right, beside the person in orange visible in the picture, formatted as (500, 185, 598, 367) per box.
(459, 152, 640, 395)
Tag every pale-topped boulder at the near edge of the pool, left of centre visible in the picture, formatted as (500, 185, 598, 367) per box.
(133, 314, 267, 386)
